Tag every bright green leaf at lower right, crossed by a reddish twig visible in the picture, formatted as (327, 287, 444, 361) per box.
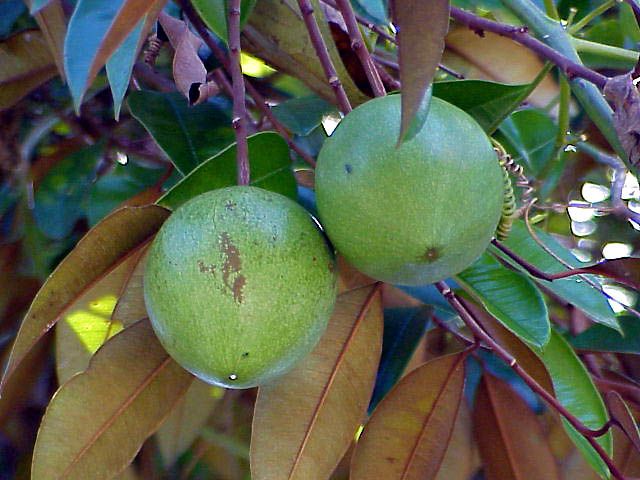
(538, 330, 613, 478)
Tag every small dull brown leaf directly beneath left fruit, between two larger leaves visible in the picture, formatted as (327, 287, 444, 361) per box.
(156, 380, 219, 467)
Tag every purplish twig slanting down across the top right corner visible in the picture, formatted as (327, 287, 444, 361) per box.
(451, 6, 609, 88)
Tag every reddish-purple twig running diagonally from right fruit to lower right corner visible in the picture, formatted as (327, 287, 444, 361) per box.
(436, 282, 625, 480)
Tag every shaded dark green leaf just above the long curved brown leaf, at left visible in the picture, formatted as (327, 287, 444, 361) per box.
(85, 162, 163, 226)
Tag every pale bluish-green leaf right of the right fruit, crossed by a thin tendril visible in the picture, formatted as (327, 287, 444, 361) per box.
(504, 220, 620, 329)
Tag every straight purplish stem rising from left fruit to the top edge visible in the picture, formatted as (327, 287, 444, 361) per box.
(228, 0, 250, 185)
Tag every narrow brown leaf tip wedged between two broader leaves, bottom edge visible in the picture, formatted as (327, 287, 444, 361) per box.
(435, 401, 480, 480)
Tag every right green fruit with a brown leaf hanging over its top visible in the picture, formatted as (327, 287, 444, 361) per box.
(315, 95, 503, 285)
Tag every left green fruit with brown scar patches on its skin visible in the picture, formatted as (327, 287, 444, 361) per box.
(144, 186, 336, 388)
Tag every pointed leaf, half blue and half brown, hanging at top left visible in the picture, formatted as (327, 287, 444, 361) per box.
(64, 0, 161, 111)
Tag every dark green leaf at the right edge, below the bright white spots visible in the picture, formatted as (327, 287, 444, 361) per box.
(569, 316, 640, 354)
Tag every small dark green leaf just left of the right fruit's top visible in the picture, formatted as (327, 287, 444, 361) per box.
(271, 95, 335, 136)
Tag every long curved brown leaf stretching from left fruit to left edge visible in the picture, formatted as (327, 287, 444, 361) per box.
(0, 205, 169, 391)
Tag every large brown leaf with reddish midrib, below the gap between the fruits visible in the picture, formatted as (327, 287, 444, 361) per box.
(251, 286, 382, 480)
